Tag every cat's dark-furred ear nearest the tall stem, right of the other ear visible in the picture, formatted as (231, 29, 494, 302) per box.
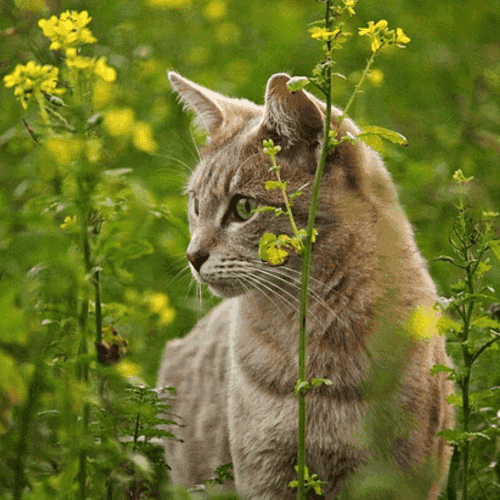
(261, 73, 324, 148)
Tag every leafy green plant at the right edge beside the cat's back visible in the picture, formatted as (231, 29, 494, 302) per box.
(431, 170, 500, 499)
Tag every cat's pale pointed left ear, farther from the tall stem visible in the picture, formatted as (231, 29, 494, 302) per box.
(168, 71, 225, 135)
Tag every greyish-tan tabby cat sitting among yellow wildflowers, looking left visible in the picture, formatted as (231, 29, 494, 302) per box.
(158, 72, 454, 500)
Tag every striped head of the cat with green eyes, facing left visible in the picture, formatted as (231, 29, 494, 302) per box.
(168, 72, 396, 297)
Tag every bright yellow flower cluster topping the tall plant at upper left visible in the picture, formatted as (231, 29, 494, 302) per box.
(38, 10, 97, 50)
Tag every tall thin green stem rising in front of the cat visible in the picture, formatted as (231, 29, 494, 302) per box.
(297, 0, 332, 500)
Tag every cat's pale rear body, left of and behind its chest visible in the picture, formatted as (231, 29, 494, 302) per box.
(157, 299, 238, 486)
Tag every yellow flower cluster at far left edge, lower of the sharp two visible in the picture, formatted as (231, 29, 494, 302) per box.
(4, 61, 64, 109)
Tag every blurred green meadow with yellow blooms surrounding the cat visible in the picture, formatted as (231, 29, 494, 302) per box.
(0, 0, 500, 499)
